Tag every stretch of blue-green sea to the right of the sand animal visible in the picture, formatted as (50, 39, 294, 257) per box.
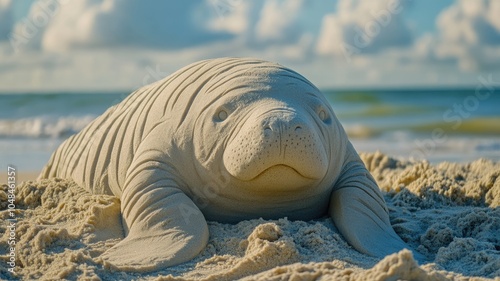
(325, 89, 500, 163)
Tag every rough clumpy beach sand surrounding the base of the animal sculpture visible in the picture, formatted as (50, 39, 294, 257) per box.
(0, 153, 500, 280)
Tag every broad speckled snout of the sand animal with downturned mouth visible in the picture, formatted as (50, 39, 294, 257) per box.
(224, 109, 328, 188)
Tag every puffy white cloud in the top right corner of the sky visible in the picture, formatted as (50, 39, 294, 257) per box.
(419, 0, 500, 71)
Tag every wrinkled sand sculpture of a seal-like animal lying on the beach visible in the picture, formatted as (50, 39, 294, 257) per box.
(40, 58, 422, 271)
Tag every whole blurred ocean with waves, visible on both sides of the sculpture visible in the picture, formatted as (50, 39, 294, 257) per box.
(0, 89, 500, 172)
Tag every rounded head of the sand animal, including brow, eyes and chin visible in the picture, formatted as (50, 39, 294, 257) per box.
(178, 59, 346, 221)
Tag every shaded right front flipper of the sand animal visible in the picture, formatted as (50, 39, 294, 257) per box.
(329, 161, 422, 260)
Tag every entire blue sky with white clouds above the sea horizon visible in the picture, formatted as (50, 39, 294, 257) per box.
(0, 0, 500, 93)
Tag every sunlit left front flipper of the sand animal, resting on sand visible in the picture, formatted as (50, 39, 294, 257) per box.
(101, 186, 208, 272)
